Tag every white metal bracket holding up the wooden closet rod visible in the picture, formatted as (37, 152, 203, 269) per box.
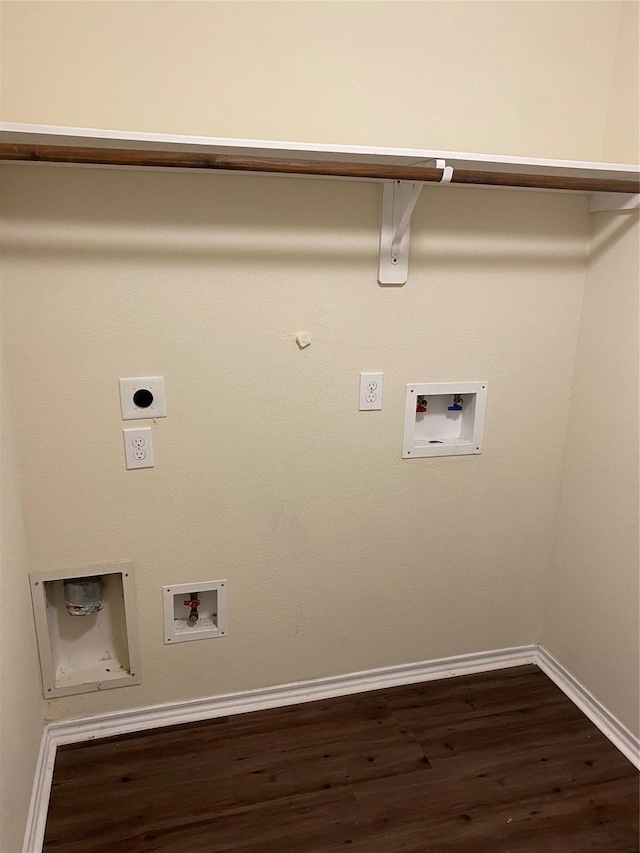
(378, 160, 453, 284)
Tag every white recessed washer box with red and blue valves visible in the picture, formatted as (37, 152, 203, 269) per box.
(402, 382, 488, 459)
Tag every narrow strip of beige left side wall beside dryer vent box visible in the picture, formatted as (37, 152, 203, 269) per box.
(0, 342, 44, 853)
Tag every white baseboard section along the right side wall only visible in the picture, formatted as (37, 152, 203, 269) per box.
(536, 646, 640, 770)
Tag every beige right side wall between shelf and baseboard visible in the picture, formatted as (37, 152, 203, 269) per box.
(542, 213, 640, 734)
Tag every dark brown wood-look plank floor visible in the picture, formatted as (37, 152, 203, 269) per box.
(44, 666, 639, 853)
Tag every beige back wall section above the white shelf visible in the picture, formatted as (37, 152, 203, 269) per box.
(0, 0, 619, 160)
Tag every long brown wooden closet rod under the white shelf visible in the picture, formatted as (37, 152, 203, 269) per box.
(0, 143, 640, 193)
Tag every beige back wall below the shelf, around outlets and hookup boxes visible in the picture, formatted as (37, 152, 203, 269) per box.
(3, 161, 587, 718)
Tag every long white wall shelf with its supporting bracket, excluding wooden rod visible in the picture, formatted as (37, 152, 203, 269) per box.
(0, 122, 640, 285)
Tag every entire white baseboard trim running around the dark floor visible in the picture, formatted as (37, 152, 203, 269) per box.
(23, 644, 640, 853)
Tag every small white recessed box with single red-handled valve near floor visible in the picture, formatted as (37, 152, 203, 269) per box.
(162, 580, 228, 645)
